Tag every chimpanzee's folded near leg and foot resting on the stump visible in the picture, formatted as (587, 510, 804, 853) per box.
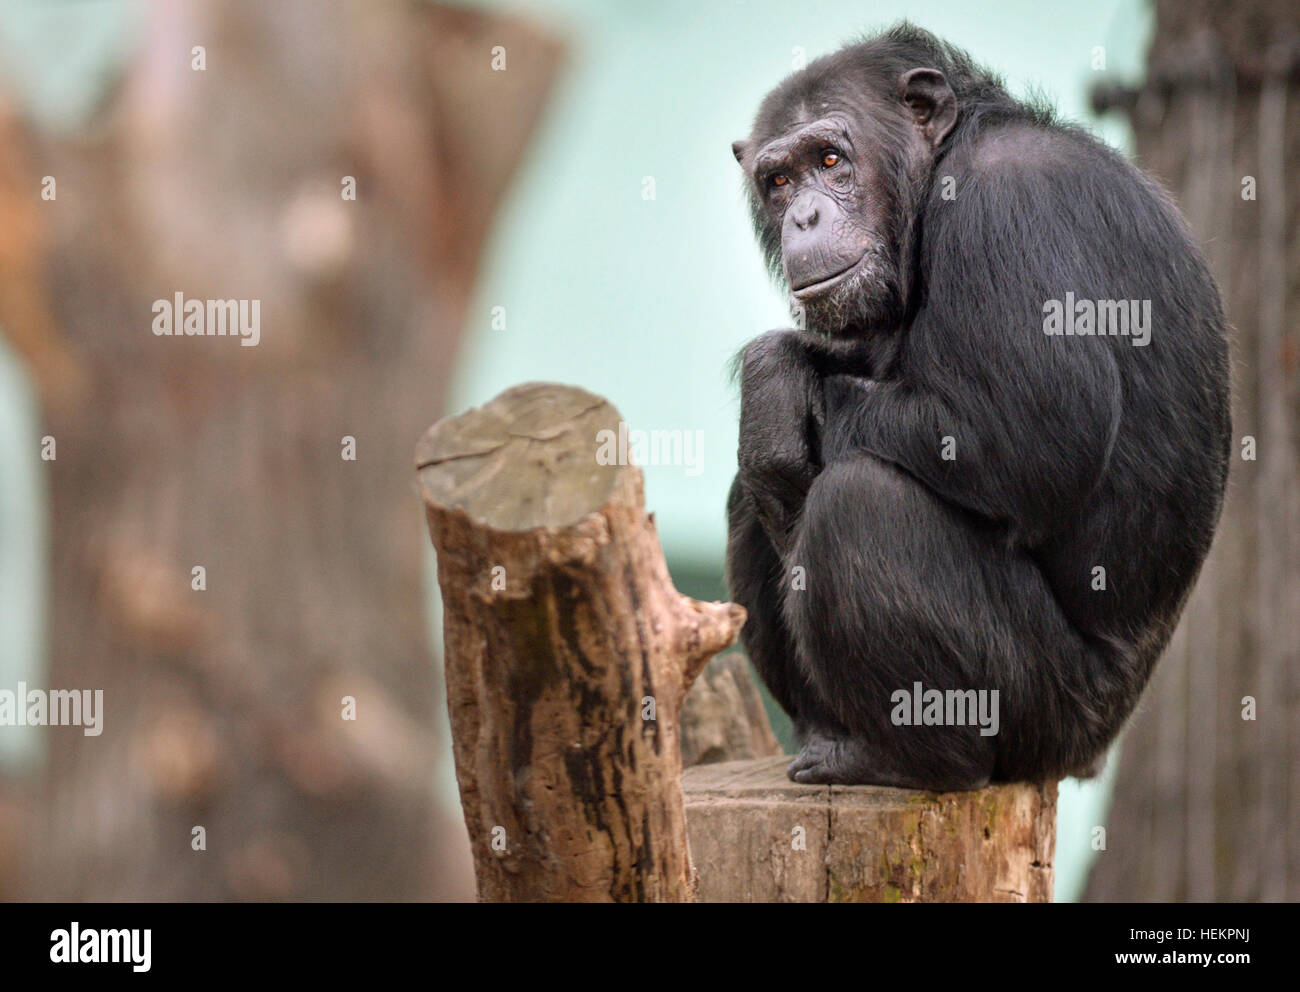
(774, 454, 1131, 789)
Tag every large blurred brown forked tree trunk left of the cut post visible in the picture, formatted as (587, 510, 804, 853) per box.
(0, 0, 559, 900)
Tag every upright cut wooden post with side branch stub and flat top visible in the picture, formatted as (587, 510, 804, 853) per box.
(416, 384, 745, 901)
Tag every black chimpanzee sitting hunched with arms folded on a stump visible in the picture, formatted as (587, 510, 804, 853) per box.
(727, 23, 1231, 789)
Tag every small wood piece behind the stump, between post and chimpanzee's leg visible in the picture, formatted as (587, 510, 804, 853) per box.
(681, 651, 781, 768)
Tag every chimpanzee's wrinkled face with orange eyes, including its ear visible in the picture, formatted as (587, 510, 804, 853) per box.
(732, 68, 957, 338)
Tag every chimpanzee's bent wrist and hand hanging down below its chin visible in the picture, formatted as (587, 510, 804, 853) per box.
(738, 330, 826, 554)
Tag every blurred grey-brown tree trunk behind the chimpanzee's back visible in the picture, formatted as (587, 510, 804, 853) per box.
(1088, 0, 1300, 901)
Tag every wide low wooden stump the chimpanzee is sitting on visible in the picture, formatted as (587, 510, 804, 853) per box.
(683, 755, 1057, 902)
